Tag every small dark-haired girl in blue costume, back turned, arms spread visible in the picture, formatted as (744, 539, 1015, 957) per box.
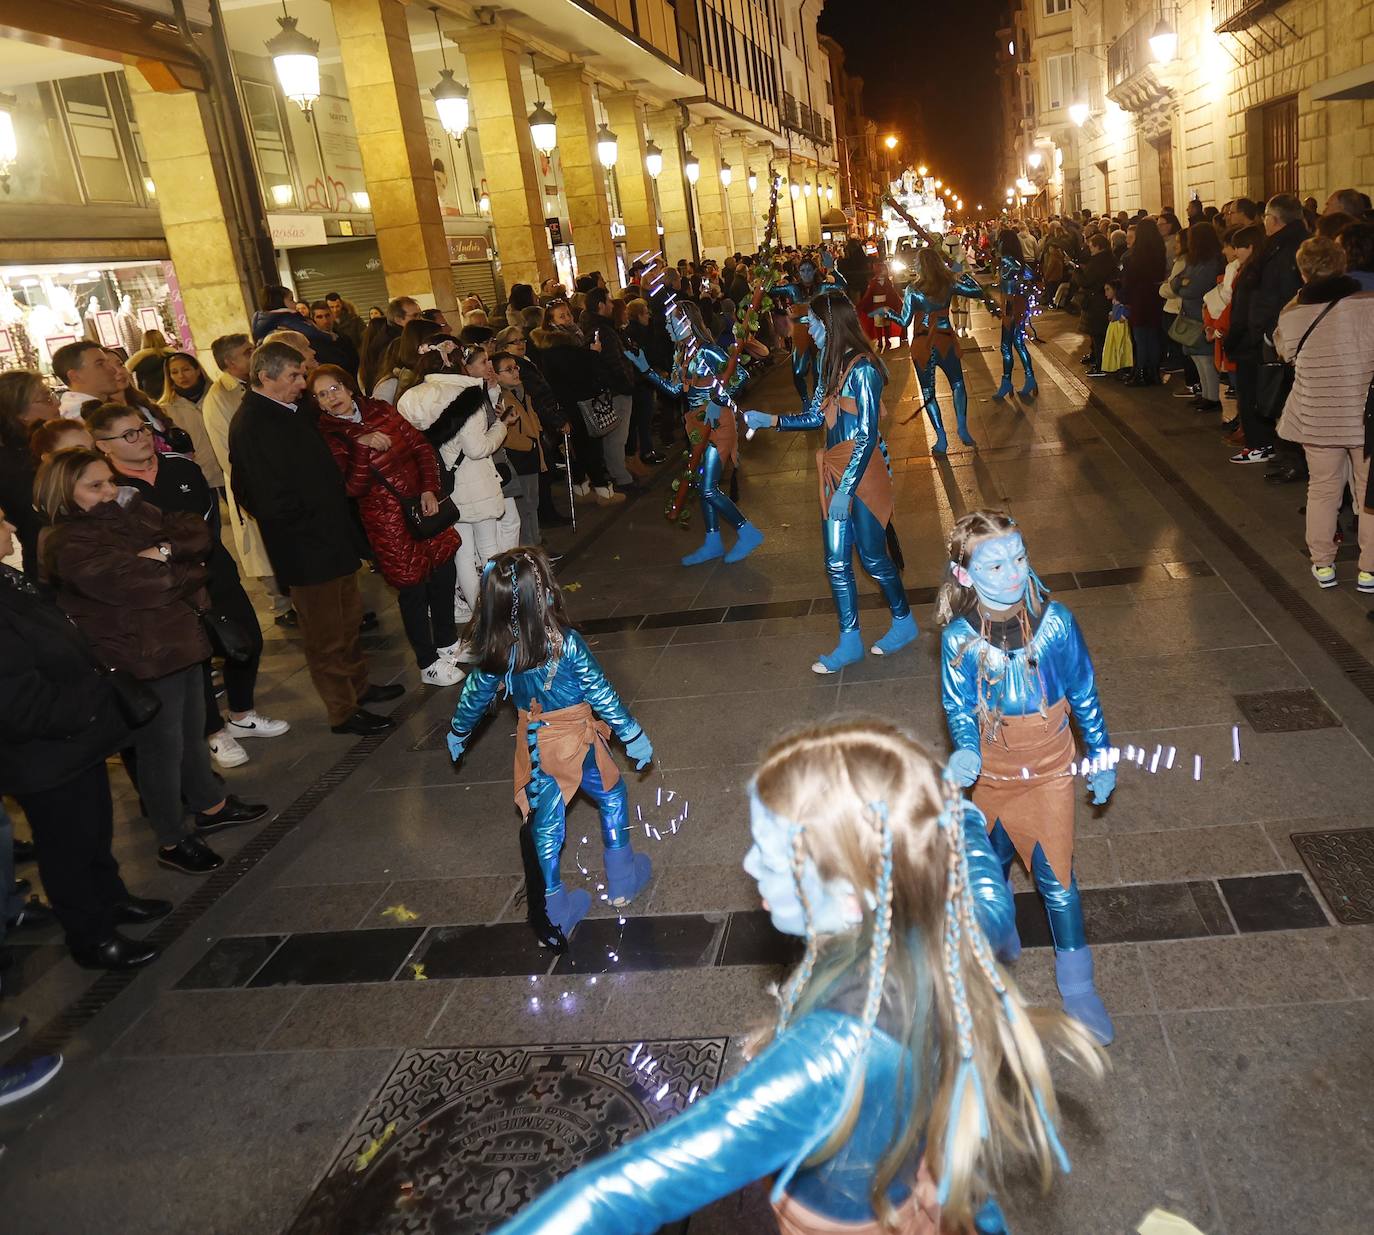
(448, 548, 654, 952)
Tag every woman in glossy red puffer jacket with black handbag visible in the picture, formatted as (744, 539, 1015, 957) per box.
(309, 364, 463, 686)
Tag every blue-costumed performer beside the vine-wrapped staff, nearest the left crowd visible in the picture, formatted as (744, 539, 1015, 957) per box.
(625, 299, 764, 566)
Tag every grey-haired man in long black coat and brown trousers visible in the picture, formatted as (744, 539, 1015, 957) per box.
(229, 343, 403, 734)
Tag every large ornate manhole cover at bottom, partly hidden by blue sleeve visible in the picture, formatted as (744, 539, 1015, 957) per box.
(290, 1039, 725, 1235)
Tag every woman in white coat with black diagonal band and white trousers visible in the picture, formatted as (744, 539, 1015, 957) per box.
(396, 335, 506, 621)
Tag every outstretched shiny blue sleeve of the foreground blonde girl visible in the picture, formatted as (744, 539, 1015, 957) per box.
(493, 1011, 861, 1235)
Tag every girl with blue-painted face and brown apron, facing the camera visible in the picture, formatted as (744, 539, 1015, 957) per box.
(936, 510, 1116, 1045)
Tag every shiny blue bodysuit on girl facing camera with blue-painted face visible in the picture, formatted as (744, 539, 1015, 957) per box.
(940, 600, 1110, 952)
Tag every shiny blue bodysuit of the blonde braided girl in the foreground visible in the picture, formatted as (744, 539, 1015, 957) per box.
(497, 809, 1015, 1235)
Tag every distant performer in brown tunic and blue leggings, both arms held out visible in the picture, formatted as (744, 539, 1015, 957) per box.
(872, 245, 999, 455)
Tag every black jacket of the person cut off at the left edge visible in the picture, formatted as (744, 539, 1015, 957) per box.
(0, 566, 129, 794)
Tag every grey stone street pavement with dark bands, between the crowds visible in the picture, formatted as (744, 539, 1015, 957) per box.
(0, 315, 1374, 1235)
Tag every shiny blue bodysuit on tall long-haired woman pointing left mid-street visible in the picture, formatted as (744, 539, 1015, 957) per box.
(778, 356, 911, 662)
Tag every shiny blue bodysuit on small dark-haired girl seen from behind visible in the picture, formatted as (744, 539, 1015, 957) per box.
(452, 631, 643, 893)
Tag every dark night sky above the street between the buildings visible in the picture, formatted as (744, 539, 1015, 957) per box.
(820, 0, 1004, 207)
